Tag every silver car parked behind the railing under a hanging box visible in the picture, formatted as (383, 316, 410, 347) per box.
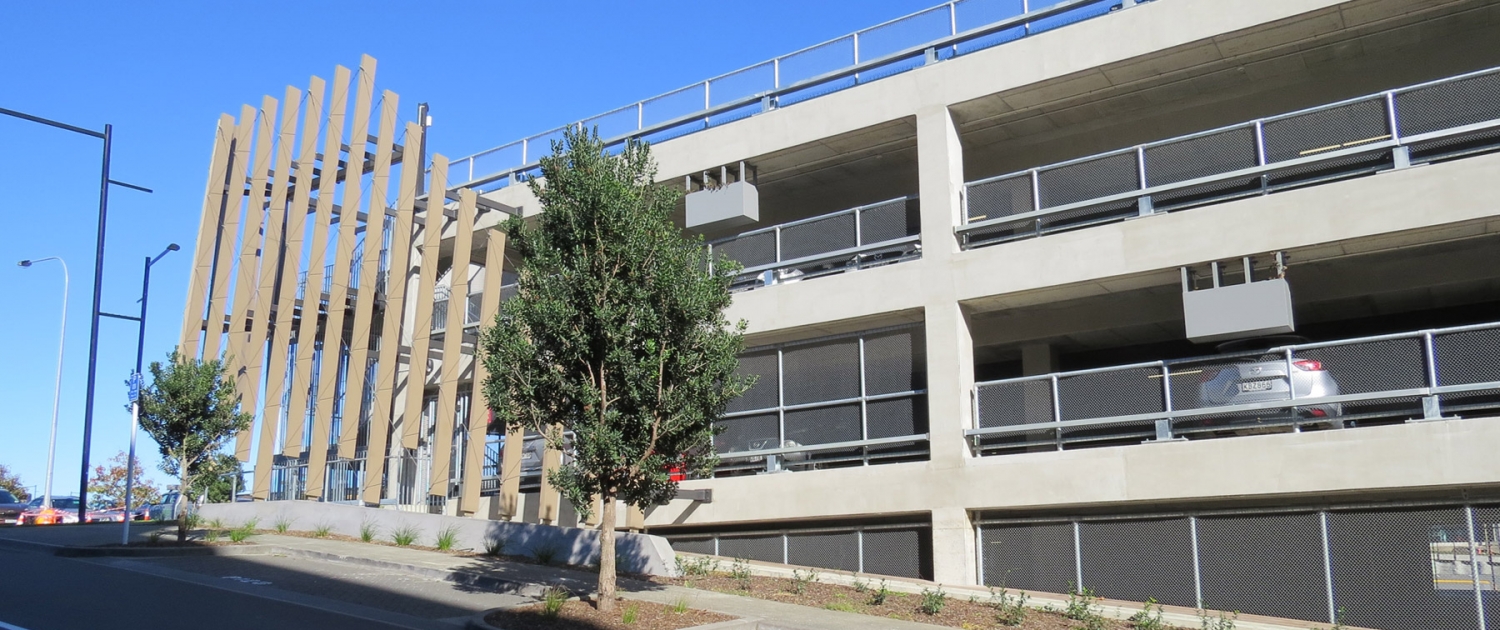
(1199, 338, 1344, 429)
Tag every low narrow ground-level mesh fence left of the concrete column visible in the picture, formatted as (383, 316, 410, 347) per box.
(662, 524, 933, 579)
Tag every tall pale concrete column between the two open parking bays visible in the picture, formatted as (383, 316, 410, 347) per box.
(917, 105, 975, 584)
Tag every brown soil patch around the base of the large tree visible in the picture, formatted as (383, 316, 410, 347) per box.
(485, 600, 734, 630)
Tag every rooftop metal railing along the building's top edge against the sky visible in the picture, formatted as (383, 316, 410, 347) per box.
(449, 0, 1137, 189)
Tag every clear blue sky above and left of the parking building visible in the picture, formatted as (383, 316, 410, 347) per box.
(0, 0, 938, 495)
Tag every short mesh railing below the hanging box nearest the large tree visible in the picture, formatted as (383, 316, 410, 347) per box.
(708, 195, 923, 291)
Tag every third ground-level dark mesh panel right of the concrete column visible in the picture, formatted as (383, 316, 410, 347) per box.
(1199, 515, 1328, 621)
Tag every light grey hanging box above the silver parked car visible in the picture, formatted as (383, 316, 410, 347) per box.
(1182, 278, 1296, 344)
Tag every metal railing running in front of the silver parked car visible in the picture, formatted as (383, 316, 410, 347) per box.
(965, 323, 1500, 438)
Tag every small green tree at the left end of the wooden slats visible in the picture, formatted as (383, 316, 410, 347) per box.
(141, 351, 252, 542)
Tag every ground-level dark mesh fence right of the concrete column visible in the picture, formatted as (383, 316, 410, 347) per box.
(975, 504, 1500, 630)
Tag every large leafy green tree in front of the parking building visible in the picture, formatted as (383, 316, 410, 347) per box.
(482, 131, 749, 611)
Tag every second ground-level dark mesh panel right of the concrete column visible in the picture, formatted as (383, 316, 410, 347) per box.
(1079, 519, 1197, 606)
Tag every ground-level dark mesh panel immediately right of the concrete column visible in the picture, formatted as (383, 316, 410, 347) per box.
(981, 524, 1077, 593)
